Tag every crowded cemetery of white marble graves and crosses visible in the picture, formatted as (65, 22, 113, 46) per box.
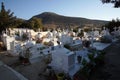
(1, 27, 120, 80)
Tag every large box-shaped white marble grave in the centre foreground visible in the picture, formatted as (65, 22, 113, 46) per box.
(50, 47, 75, 73)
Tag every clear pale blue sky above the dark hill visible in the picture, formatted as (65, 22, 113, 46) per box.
(0, 0, 120, 20)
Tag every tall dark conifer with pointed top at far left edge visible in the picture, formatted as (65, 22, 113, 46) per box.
(0, 2, 16, 33)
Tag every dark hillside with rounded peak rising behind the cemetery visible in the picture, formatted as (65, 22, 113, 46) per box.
(33, 12, 108, 26)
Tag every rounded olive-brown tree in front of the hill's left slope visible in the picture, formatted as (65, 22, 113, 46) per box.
(29, 17, 43, 30)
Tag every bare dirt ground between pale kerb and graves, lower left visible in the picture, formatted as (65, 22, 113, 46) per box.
(0, 51, 47, 80)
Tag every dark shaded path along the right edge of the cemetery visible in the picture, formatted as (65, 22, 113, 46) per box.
(89, 40, 120, 80)
